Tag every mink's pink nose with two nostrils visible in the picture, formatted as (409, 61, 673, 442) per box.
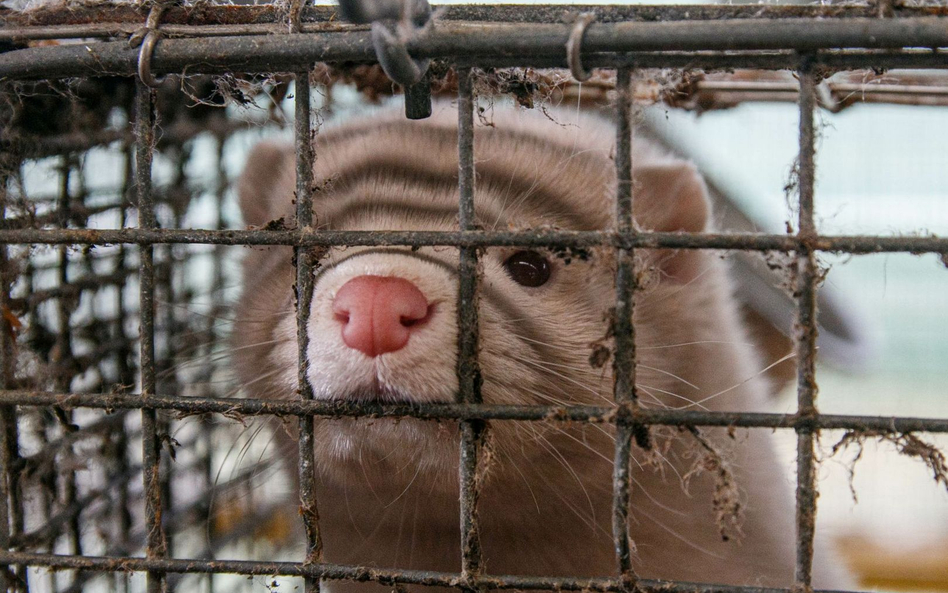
(332, 276, 430, 357)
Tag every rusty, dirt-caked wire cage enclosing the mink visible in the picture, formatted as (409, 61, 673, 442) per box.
(0, 0, 948, 591)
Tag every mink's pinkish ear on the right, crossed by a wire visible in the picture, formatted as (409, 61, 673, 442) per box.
(634, 160, 711, 283)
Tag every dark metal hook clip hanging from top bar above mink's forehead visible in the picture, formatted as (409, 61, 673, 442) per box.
(339, 0, 431, 119)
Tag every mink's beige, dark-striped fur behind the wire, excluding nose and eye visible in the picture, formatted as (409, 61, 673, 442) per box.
(235, 105, 841, 590)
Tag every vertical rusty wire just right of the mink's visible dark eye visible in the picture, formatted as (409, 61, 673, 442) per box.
(612, 68, 645, 587)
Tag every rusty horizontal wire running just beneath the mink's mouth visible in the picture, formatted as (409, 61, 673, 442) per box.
(0, 390, 948, 433)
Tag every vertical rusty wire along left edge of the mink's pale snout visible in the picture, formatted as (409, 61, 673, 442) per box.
(294, 70, 322, 592)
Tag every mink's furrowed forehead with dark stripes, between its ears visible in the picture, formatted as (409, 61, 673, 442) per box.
(315, 117, 614, 230)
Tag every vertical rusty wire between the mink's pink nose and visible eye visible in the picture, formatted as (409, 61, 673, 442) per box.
(457, 68, 487, 578)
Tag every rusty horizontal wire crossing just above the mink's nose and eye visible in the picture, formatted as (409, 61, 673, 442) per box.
(0, 229, 948, 254)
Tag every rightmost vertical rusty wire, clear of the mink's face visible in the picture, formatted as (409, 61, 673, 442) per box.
(795, 58, 819, 591)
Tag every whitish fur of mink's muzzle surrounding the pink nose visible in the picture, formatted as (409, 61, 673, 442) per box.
(274, 253, 457, 402)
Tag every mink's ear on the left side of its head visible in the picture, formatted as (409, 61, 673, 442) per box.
(237, 142, 295, 227)
